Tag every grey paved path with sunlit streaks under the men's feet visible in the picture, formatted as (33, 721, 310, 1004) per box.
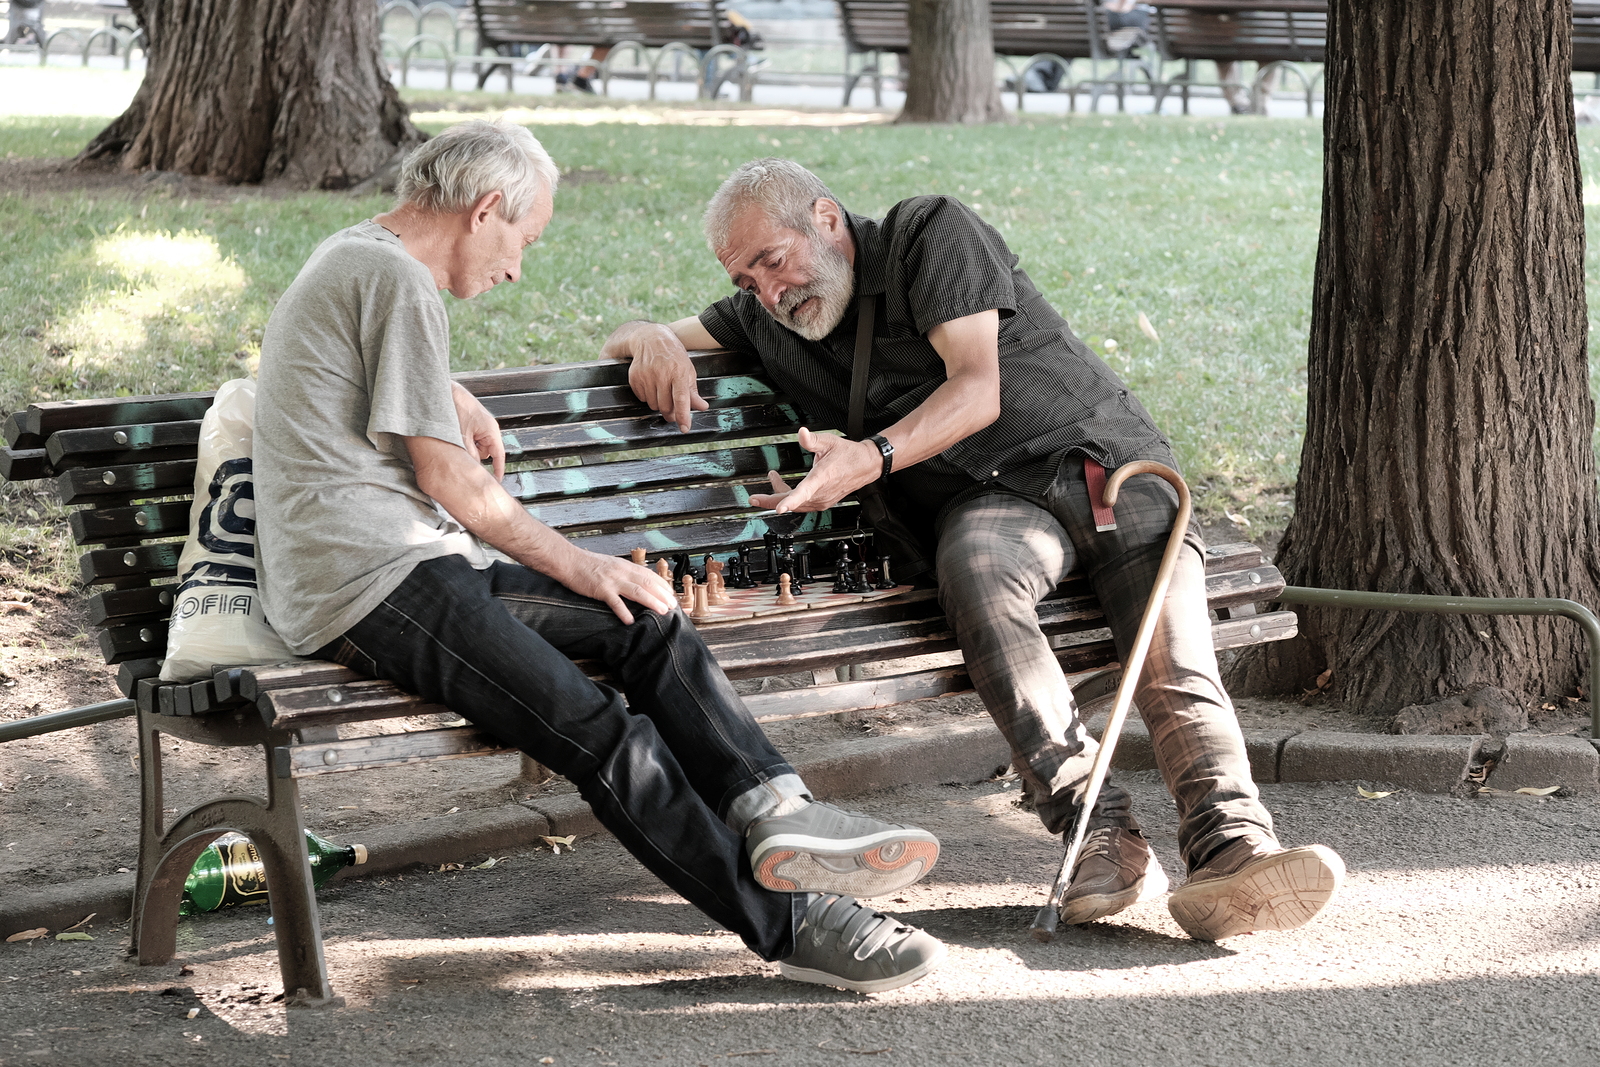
(0, 773, 1600, 1067)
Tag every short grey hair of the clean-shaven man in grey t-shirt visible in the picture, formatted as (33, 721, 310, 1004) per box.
(395, 118, 562, 222)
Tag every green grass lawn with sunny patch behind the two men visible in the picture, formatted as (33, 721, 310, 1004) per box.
(0, 93, 1600, 556)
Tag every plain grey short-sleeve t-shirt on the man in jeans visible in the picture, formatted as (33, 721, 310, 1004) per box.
(254, 222, 488, 656)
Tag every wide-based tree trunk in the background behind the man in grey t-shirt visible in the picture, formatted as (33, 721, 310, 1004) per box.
(78, 0, 424, 189)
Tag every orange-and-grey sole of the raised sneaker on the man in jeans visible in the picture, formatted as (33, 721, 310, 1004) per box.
(750, 830, 939, 899)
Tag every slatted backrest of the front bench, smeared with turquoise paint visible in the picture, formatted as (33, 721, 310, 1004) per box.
(0, 352, 856, 684)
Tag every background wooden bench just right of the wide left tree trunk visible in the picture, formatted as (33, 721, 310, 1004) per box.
(472, 0, 755, 101)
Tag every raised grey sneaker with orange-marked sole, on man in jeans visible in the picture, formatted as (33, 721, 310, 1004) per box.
(744, 803, 939, 896)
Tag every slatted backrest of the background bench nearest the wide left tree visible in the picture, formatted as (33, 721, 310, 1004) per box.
(474, 0, 726, 48)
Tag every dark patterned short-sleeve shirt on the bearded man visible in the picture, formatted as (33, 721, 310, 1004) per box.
(699, 195, 1173, 512)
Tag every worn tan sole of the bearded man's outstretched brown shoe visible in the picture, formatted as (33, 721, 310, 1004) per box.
(1166, 845, 1344, 941)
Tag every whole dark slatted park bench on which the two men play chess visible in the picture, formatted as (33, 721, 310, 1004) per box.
(0, 352, 1296, 1003)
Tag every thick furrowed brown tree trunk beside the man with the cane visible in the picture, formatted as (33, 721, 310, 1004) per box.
(1243, 0, 1600, 710)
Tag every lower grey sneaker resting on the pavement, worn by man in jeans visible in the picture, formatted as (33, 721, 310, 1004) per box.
(778, 893, 944, 993)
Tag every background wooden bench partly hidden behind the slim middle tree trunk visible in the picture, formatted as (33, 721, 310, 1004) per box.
(838, 0, 1162, 110)
